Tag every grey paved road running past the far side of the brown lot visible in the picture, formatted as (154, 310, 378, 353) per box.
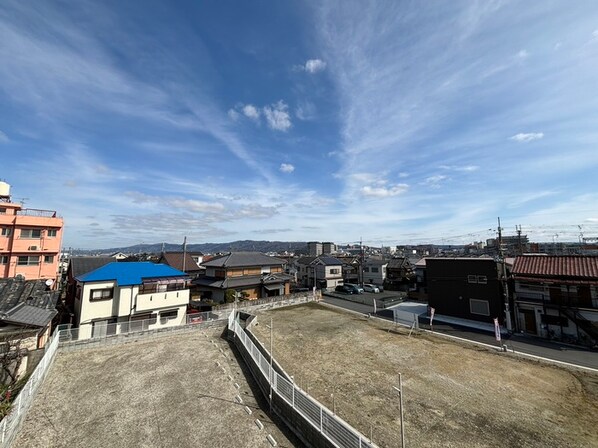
(323, 296, 598, 369)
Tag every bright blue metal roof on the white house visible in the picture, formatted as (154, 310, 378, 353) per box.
(77, 261, 187, 286)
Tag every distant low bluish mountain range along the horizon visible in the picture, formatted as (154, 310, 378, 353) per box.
(73, 240, 307, 255)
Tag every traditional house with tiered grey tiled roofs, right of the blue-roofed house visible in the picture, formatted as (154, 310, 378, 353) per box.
(192, 252, 292, 303)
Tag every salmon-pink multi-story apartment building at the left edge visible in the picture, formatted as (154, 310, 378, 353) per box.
(0, 181, 63, 280)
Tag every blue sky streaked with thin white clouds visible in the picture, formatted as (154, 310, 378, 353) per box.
(0, 0, 598, 248)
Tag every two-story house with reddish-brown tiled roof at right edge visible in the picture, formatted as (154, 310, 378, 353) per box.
(512, 255, 598, 345)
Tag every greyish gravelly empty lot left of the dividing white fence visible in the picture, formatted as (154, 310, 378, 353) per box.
(13, 329, 300, 448)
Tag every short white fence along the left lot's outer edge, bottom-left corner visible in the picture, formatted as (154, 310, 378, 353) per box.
(0, 337, 59, 447)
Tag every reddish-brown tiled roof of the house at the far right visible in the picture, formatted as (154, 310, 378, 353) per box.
(511, 255, 598, 279)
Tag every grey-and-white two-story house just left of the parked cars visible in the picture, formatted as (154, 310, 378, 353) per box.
(296, 255, 343, 289)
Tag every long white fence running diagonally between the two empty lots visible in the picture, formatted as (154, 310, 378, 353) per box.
(228, 311, 376, 448)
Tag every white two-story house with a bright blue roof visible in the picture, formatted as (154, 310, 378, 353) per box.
(74, 261, 189, 339)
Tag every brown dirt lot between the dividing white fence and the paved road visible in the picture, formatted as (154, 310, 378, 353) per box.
(254, 304, 598, 447)
